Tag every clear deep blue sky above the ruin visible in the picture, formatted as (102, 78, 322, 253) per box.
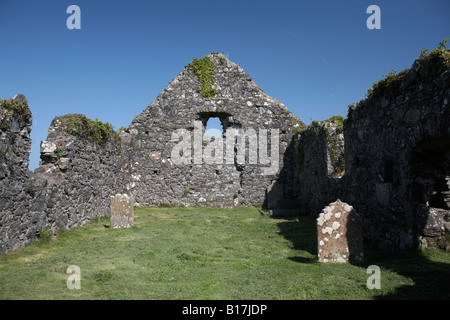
(0, 0, 450, 170)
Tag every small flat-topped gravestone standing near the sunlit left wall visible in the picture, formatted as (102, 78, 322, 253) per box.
(110, 194, 134, 228)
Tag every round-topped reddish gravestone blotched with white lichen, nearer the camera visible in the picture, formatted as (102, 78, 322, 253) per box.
(317, 200, 364, 263)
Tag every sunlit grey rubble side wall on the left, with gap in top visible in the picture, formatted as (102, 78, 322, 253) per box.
(0, 106, 120, 253)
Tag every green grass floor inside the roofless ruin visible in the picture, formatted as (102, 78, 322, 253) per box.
(0, 207, 450, 300)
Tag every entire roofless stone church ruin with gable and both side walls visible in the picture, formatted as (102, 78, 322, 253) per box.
(0, 50, 450, 255)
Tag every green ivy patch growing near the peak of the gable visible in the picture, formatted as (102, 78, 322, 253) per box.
(189, 56, 216, 98)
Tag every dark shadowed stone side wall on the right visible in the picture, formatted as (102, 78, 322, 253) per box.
(299, 52, 450, 254)
